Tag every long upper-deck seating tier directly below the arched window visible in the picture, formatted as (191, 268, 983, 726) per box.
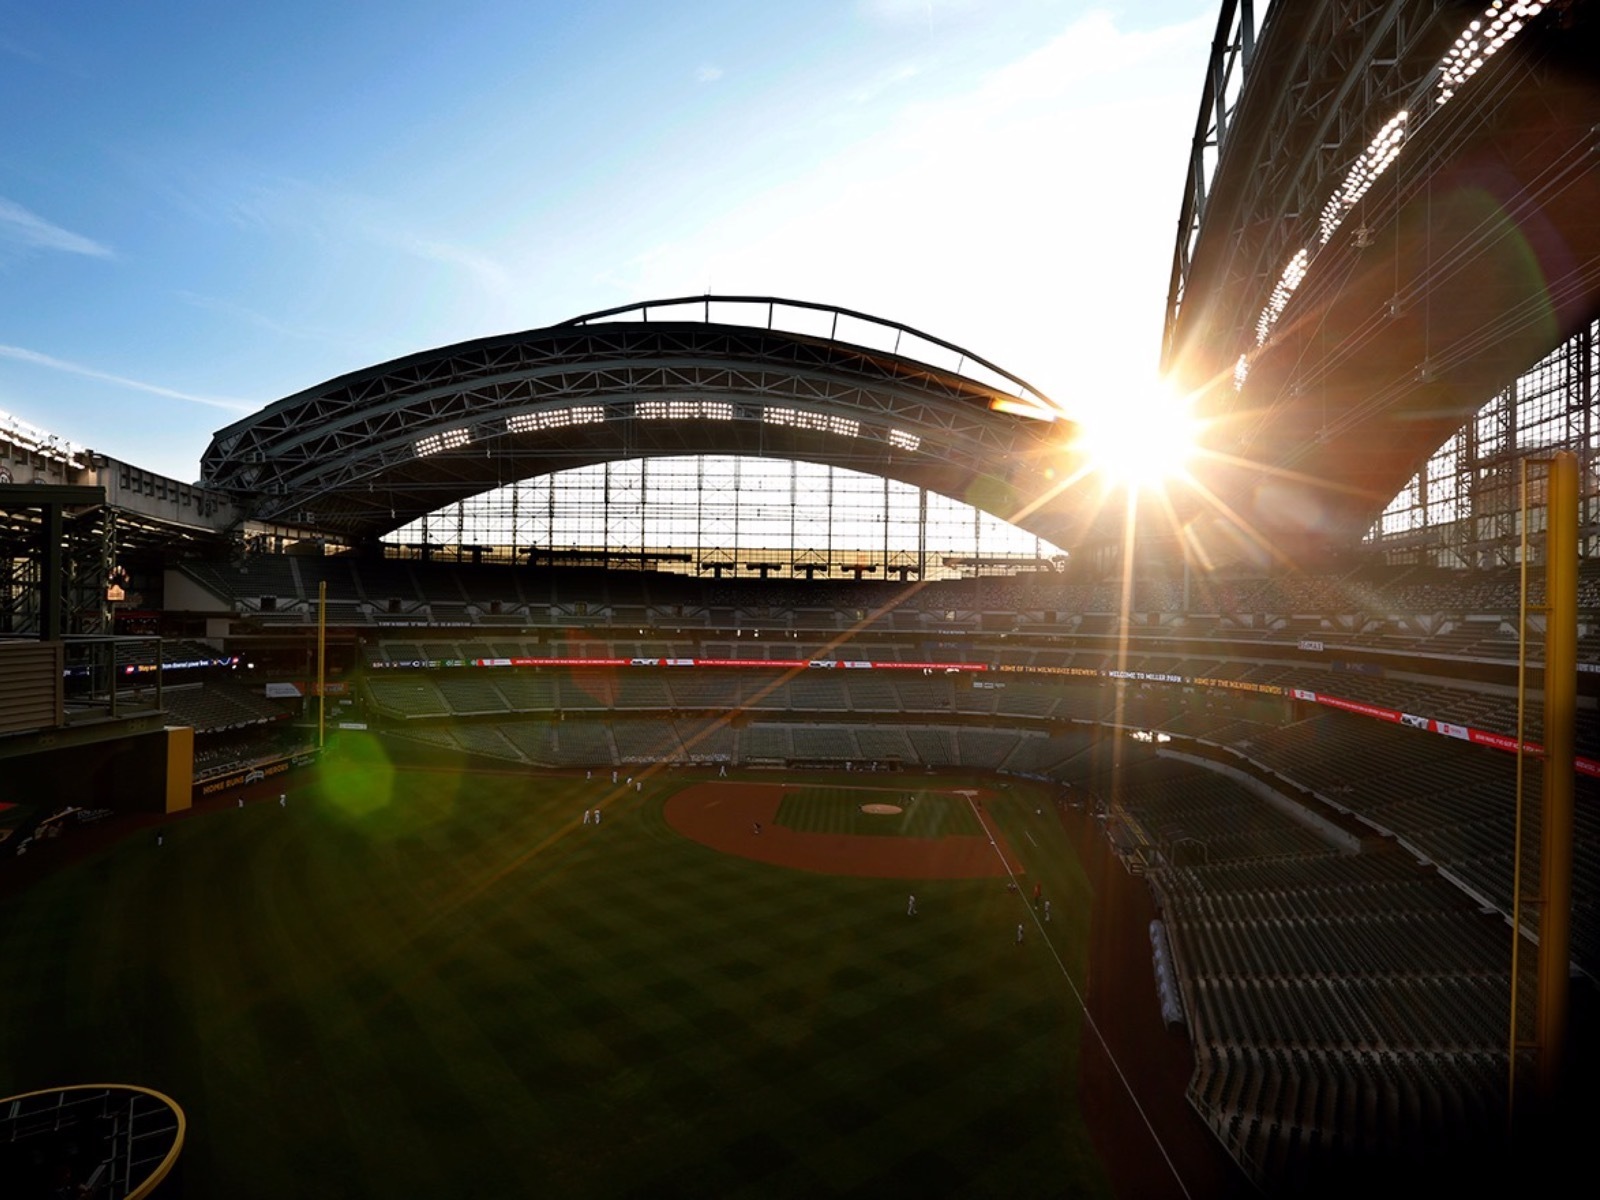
(179, 554, 1600, 678)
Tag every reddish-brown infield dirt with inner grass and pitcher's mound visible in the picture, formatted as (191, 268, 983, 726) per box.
(666, 779, 1022, 878)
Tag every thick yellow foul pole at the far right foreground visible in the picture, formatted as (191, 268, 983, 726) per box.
(1538, 451, 1578, 1101)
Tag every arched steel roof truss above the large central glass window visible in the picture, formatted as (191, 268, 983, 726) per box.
(202, 296, 1100, 544)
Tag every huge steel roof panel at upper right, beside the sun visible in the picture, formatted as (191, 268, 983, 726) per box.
(1163, 0, 1600, 544)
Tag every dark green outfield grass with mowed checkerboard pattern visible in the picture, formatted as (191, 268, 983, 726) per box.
(0, 748, 1106, 1200)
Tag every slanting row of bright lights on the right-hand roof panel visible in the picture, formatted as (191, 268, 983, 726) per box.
(1234, 0, 1547, 390)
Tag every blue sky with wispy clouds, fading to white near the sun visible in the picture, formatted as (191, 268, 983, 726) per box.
(0, 0, 1216, 478)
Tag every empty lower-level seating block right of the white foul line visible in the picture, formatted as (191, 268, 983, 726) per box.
(1102, 765, 1509, 1195)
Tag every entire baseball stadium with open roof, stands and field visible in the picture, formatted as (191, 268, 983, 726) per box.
(0, 0, 1600, 1200)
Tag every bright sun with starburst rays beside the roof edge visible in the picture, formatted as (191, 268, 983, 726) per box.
(1072, 382, 1200, 491)
